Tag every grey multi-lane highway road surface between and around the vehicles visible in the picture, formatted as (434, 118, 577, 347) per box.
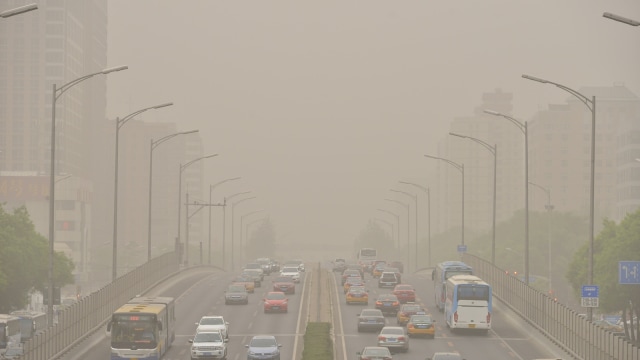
(64, 264, 566, 360)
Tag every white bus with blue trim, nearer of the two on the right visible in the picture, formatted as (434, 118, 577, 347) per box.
(444, 275, 492, 333)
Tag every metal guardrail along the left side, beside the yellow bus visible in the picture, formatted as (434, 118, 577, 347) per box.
(20, 252, 179, 360)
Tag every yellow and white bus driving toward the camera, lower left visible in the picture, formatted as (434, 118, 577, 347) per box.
(107, 297, 176, 360)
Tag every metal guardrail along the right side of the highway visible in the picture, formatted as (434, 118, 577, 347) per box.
(464, 254, 640, 360)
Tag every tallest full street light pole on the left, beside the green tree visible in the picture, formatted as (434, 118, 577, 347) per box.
(47, 66, 129, 326)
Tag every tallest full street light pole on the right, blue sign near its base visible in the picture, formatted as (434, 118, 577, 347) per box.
(522, 75, 596, 321)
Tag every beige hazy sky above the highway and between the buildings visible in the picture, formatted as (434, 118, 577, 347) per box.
(107, 0, 640, 248)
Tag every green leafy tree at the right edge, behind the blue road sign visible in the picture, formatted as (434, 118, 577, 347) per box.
(567, 210, 640, 344)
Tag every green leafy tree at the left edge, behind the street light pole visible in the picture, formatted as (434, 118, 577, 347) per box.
(0, 206, 74, 313)
